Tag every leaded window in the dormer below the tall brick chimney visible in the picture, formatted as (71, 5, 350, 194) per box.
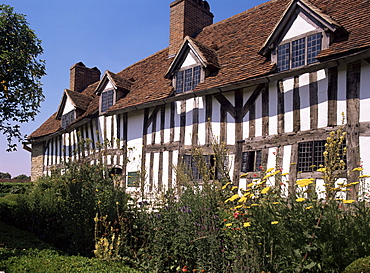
(176, 66, 201, 94)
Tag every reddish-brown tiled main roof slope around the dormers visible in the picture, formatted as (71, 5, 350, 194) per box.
(31, 0, 370, 140)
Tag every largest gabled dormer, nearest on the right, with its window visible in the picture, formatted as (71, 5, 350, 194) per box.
(259, 0, 345, 71)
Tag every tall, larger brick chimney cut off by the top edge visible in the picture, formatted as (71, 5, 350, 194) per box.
(169, 0, 213, 56)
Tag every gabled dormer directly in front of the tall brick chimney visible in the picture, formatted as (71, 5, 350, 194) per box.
(165, 36, 220, 94)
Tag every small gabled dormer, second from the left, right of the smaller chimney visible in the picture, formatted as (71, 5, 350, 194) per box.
(95, 71, 133, 114)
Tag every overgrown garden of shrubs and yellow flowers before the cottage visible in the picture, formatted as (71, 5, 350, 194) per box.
(0, 130, 370, 273)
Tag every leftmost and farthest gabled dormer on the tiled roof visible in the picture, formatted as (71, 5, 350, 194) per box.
(56, 89, 92, 128)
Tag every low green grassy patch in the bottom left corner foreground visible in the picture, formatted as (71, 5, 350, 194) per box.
(0, 222, 139, 273)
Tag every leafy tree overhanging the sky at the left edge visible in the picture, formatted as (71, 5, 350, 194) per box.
(0, 5, 46, 151)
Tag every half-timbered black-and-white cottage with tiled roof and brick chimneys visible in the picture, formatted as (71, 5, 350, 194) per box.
(28, 0, 370, 198)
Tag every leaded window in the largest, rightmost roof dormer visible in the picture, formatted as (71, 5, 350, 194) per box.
(277, 33, 322, 71)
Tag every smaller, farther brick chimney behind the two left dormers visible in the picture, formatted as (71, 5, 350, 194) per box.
(69, 62, 100, 92)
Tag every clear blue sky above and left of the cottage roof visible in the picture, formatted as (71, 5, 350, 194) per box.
(0, 0, 267, 177)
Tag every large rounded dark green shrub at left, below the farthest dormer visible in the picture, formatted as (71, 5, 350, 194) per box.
(13, 159, 127, 256)
